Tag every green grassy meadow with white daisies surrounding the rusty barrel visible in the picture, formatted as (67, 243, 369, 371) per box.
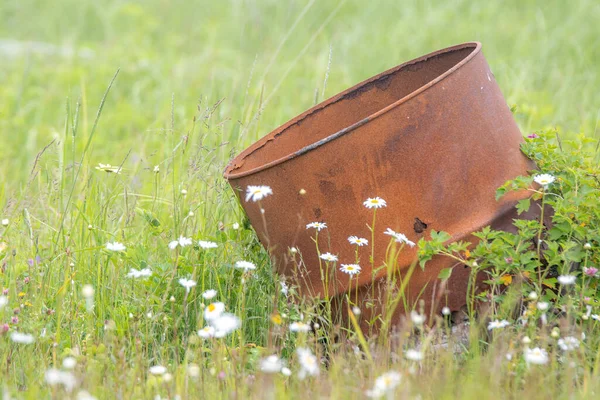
(0, 0, 600, 399)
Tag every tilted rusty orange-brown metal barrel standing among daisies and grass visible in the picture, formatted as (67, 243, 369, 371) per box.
(225, 43, 534, 324)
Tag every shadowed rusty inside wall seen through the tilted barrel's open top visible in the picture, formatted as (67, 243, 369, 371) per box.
(226, 43, 477, 174)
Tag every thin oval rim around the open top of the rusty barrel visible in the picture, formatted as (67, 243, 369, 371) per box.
(223, 42, 481, 180)
